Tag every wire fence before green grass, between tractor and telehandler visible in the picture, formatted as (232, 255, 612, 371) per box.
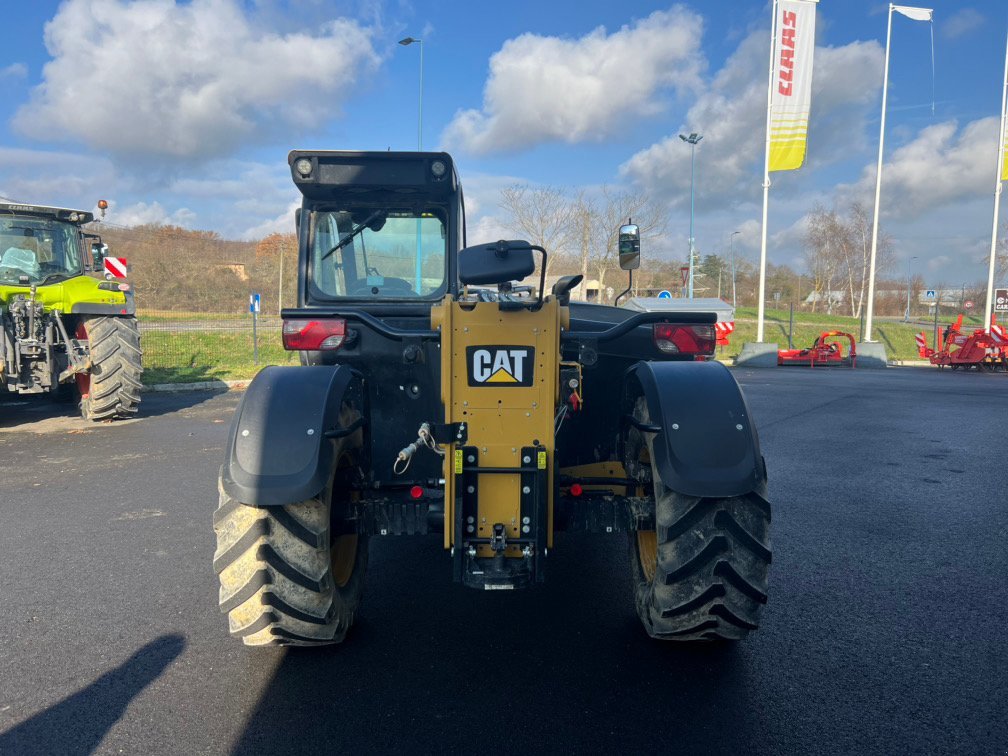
(138, 312, 297, 383)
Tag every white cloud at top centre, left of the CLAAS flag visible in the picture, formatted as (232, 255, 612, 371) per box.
(442, 6, 704, 154)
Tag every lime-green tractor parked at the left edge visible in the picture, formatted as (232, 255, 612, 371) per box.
(0, 203, 143, 420)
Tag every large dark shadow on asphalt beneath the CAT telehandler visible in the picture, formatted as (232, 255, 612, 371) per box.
(233, 535, 762, 754)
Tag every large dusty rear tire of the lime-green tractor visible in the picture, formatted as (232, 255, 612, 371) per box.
(76, 316, 143, 420)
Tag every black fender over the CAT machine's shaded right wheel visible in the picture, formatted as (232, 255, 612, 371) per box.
(623, 362, 766, 498)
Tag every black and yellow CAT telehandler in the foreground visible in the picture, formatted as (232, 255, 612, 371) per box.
(214, 151, 770, 645)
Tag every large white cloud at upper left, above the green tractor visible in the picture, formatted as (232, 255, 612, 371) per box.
(13, 0, 379, 159)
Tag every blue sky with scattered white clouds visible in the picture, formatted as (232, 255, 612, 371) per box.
(0, 0, 1008, 285)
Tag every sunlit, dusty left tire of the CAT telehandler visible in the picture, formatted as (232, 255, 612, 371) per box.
(214, 461, 368, 646)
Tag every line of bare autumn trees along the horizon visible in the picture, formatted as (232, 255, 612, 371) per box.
(91, 192, 1008, 317)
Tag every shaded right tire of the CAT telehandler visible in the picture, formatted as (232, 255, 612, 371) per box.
(630, 399, 771, 641)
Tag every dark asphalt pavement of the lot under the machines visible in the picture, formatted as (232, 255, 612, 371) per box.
(0, 368, 1008, 754)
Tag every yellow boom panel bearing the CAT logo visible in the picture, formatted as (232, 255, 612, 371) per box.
(431, 299, 566, 556)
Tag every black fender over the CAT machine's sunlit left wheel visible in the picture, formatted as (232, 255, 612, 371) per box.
(221, 365, 363, 507)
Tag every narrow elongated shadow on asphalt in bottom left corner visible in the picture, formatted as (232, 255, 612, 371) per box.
(0, 635, 185, 754)
